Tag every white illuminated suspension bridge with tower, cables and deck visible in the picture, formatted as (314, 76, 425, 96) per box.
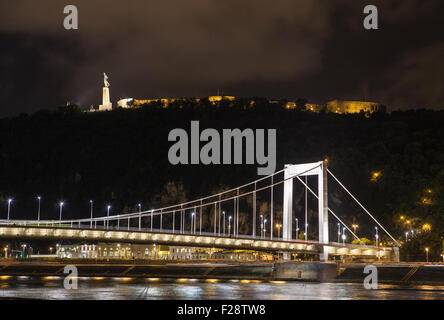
(0, 161, 399, 261)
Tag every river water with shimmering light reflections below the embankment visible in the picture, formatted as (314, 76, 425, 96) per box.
(0, 277, 444, 300)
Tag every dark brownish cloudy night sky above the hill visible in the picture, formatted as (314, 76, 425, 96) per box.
(0, 0, 444, 117)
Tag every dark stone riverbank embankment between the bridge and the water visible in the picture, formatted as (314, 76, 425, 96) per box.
(0, 260, 444, 285)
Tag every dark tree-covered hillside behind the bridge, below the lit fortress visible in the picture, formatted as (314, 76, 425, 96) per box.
(0, 98, 444, 260)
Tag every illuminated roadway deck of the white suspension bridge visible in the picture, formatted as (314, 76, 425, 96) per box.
(0, 225, 398, 261)
